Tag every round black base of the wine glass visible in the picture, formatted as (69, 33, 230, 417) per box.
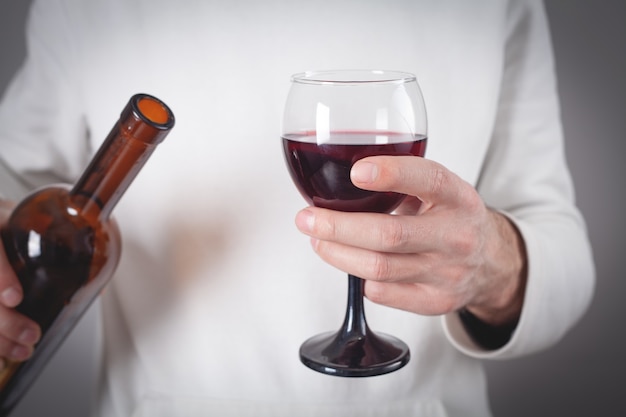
(300, 331, 410, 377)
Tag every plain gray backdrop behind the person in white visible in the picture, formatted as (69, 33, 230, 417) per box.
(0, 0, 626, 417)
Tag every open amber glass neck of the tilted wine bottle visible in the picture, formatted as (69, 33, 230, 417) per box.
(70, 94, 174, 220)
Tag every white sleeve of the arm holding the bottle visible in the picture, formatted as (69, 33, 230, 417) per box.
(0, 0, 89, 199)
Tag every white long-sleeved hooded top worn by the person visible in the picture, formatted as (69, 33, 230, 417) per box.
(0, 0, 593, 417)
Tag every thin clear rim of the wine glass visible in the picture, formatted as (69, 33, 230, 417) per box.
(291, 69, 417, 85)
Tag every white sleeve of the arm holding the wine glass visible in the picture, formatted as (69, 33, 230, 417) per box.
(443, 0, 595, 359)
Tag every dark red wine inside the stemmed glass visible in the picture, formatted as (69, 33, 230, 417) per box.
(282, 132, 427, 213)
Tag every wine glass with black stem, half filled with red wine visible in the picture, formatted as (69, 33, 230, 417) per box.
(282, 70, 427, 377)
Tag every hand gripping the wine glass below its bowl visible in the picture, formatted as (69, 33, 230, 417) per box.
(296, 156, 526, 326)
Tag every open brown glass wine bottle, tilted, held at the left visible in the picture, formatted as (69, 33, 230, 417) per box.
(0, 94, 174, 416)
